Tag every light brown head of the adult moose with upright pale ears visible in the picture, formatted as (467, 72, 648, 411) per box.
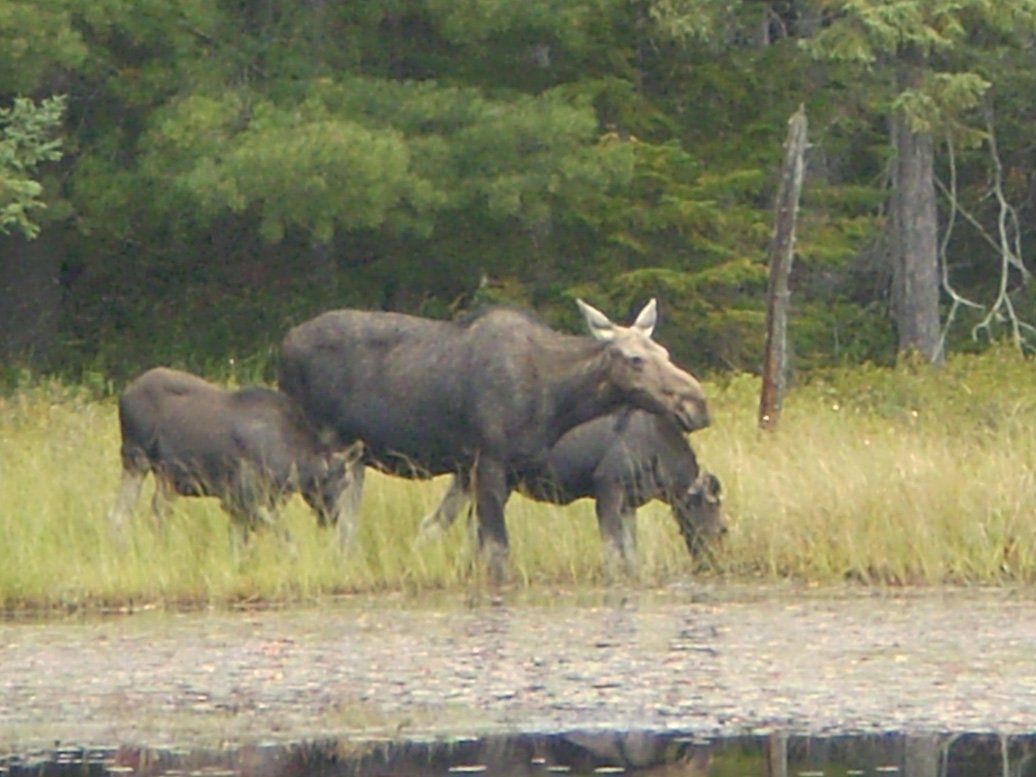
(576, 299, 710, 432)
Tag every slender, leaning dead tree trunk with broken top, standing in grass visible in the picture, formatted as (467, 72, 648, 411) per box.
(759, 107, 808, 429)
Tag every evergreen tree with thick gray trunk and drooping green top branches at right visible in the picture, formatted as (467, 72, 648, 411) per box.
(811, 0, 1036, 362)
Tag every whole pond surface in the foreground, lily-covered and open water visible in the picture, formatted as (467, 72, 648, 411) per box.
(0, 584, 1036, 777)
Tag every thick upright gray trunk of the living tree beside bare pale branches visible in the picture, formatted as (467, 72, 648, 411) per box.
(889, 65, 943, 363)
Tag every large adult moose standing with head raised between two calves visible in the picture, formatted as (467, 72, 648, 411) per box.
(279, 299, 709, 580)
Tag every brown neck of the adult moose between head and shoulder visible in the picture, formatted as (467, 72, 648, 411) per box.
(543, 337, 623, 443)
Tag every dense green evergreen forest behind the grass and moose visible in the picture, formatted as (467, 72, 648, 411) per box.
(0, 0, 1036, 389)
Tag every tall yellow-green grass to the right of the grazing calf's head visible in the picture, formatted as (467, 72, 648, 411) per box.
(697, 350, 1036, 583)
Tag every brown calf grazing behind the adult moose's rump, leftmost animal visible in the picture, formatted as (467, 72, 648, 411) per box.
(109, 367, 358, 542)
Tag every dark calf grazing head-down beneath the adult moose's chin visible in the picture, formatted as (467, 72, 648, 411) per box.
(421, 410, 726, 574)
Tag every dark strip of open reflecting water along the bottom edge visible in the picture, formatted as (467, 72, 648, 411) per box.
(0, 731, 1036, 777)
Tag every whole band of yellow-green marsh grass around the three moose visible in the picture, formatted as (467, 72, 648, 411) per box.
(0, 351, 1036, 610)
